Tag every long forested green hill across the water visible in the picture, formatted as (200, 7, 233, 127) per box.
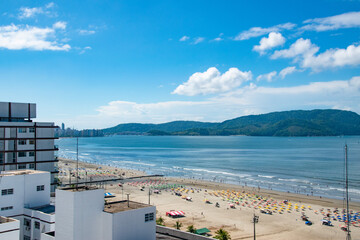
(103, 110, 360, 136)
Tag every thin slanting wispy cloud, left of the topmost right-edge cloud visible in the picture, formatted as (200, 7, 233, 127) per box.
(234, 23, 296, 40)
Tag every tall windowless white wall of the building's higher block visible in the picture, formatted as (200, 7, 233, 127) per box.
(55, 189, 104, 240)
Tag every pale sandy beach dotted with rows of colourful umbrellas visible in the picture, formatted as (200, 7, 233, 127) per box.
(58, 159, 360, 240)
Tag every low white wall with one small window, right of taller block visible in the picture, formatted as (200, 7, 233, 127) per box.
(103, 206, 156, 240)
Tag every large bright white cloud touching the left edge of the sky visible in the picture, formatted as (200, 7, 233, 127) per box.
(0, 24, 71, 51)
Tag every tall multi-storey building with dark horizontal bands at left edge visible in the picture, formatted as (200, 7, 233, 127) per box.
(0, 102, 58, 191)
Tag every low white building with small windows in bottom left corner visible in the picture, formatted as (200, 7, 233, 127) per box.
(0, 170, 55, 240)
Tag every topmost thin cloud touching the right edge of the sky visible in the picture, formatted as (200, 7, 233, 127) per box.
(301, 12, 360, 32)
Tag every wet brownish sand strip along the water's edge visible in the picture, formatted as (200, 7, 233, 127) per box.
(58, 157, 360, 210)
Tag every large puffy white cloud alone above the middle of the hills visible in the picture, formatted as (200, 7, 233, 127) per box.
(172, 67, 252, 96)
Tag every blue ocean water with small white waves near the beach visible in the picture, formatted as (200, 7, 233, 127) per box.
(56, 136, 360, 201)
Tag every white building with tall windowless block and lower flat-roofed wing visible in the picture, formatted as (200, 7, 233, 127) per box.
(41, 187, 156, 240)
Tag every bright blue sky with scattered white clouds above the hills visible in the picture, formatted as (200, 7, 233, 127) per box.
(0, 0, 360, 129)
